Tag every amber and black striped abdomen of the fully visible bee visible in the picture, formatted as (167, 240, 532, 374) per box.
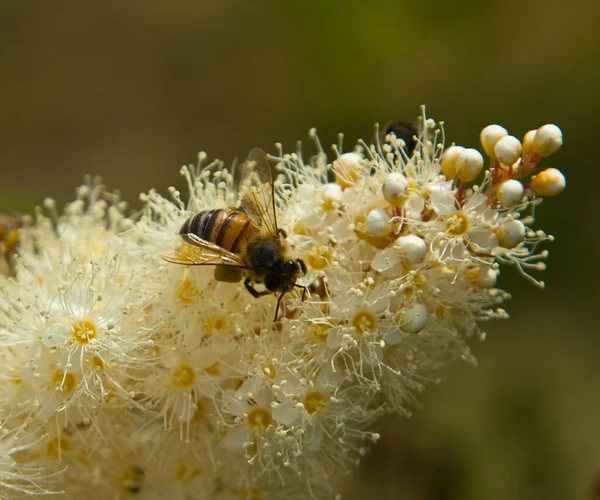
(180, 208, 257, 253)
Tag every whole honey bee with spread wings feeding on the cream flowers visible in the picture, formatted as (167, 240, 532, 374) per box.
(162, 148, 307, 321)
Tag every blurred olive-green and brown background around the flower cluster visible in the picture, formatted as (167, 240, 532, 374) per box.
(0, 0, 600, 500)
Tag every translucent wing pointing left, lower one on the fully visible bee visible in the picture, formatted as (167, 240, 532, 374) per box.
(162, 233, 246, 268)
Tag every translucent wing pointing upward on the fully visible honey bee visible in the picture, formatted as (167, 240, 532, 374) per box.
(235, 148, 277, 236)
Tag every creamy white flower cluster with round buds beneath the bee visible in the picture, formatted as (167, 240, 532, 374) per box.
(0, 110, 565, 500)
